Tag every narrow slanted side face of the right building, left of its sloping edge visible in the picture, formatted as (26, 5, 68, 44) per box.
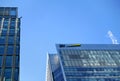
(46, 54, 64, 81)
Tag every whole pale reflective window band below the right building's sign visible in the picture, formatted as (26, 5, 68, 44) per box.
(60, 51, 120, 66)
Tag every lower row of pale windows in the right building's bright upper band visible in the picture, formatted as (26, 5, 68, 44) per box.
(62, 59, 120, 67)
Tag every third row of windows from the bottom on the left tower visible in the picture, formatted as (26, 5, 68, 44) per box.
(0, 45, 20, 55)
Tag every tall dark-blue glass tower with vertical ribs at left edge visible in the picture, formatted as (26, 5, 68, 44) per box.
(0, 7, 20, 81)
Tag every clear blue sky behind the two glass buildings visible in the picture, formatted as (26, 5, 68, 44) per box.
(0, 0, 120, 81)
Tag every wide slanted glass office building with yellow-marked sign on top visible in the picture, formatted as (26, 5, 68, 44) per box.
(46, 44, 120, 81)
